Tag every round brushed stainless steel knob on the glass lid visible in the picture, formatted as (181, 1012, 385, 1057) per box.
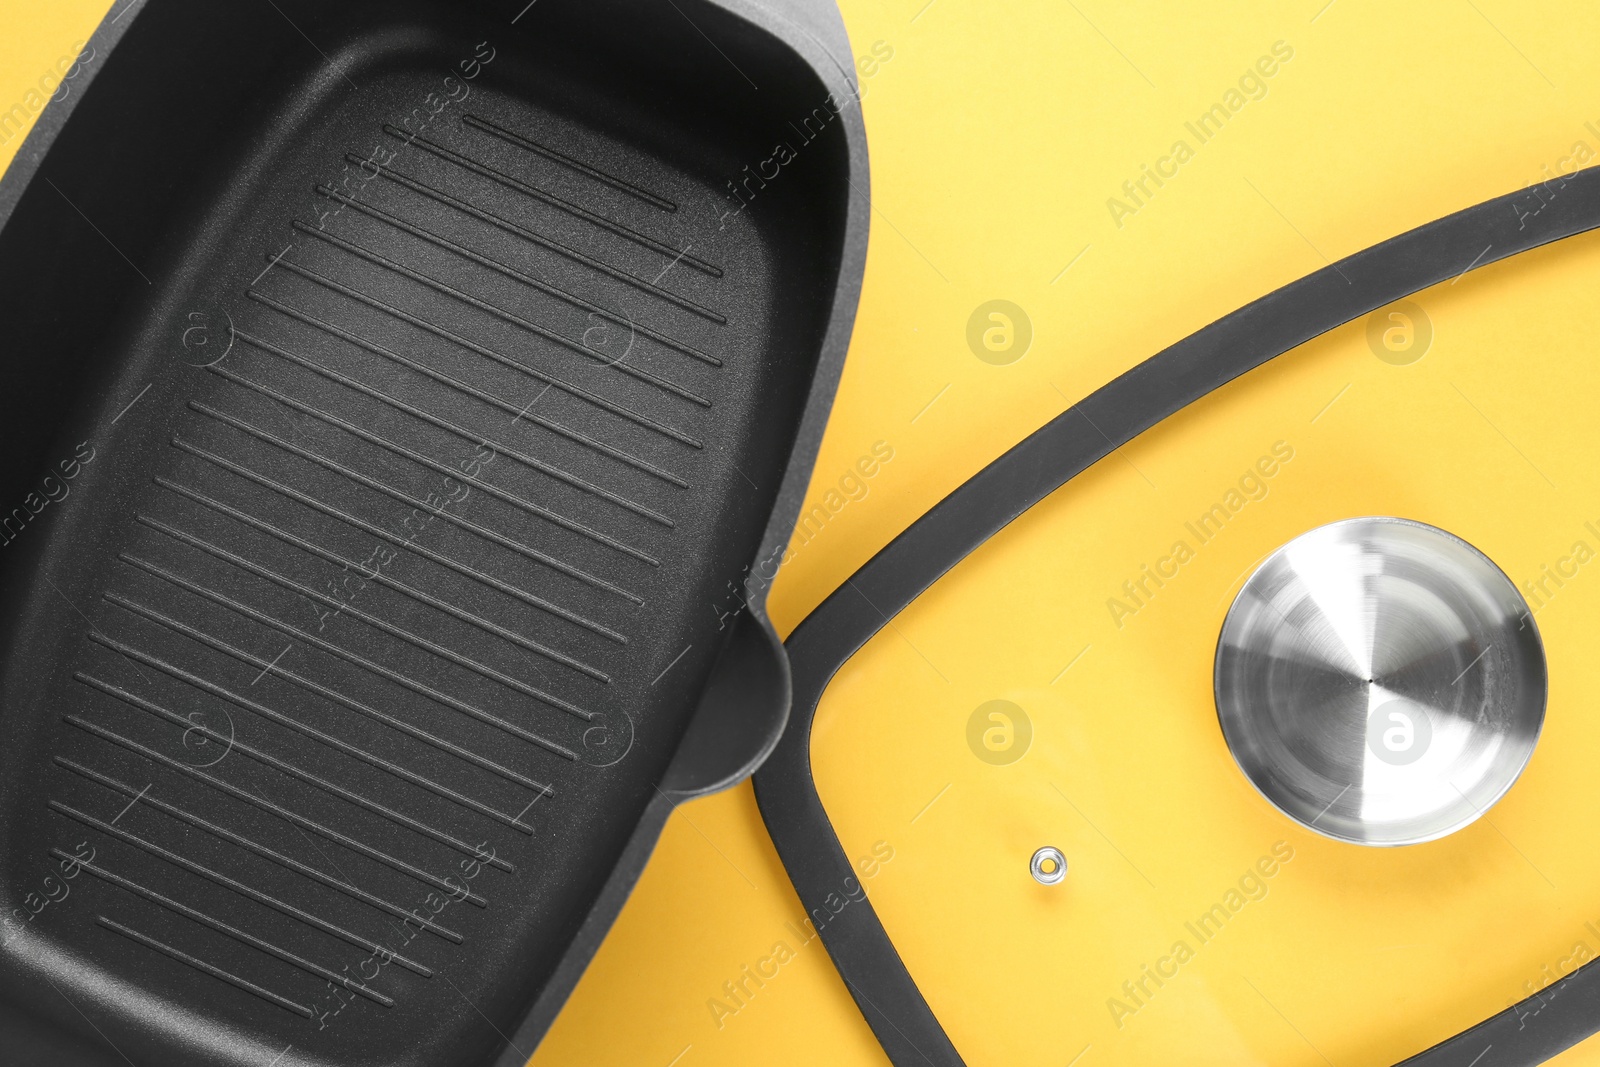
(1216, 518, 1546, 845)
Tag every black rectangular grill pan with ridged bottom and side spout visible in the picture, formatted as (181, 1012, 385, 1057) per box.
(0, 0, 866, 1067)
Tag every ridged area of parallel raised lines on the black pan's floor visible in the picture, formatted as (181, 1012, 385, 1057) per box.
(21, 81, 771, 1059)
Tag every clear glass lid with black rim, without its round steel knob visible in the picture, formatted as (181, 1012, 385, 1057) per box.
(757, 173, 1600, 1064)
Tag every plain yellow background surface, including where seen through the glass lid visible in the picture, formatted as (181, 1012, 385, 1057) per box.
(0, 0, 1600, 1067)
